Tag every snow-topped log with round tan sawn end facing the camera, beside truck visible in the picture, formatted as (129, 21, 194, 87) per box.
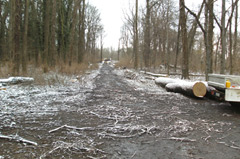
(165, 81, 207, 98)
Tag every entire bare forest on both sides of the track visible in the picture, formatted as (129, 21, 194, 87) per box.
(0, 0, 240, 79)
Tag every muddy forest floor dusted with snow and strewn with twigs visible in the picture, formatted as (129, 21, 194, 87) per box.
(0, 64, 240, 159)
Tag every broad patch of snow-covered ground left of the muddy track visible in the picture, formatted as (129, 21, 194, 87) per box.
(0, 67, 99, 127)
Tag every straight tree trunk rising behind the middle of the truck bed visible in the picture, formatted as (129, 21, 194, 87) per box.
(220, 0, 226, 74)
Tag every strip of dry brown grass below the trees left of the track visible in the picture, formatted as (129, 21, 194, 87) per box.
(0, 62, 98, 85)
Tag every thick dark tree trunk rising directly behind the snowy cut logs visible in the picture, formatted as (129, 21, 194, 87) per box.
(179, 0, 189, 79)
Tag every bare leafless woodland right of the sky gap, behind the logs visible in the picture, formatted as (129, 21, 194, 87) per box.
(119, 0, 240, 79)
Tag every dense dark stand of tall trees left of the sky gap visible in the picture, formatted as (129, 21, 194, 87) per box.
(0, 0, 103, 75)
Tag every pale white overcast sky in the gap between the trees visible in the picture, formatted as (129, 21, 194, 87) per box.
(88, 0, 212, 49)
